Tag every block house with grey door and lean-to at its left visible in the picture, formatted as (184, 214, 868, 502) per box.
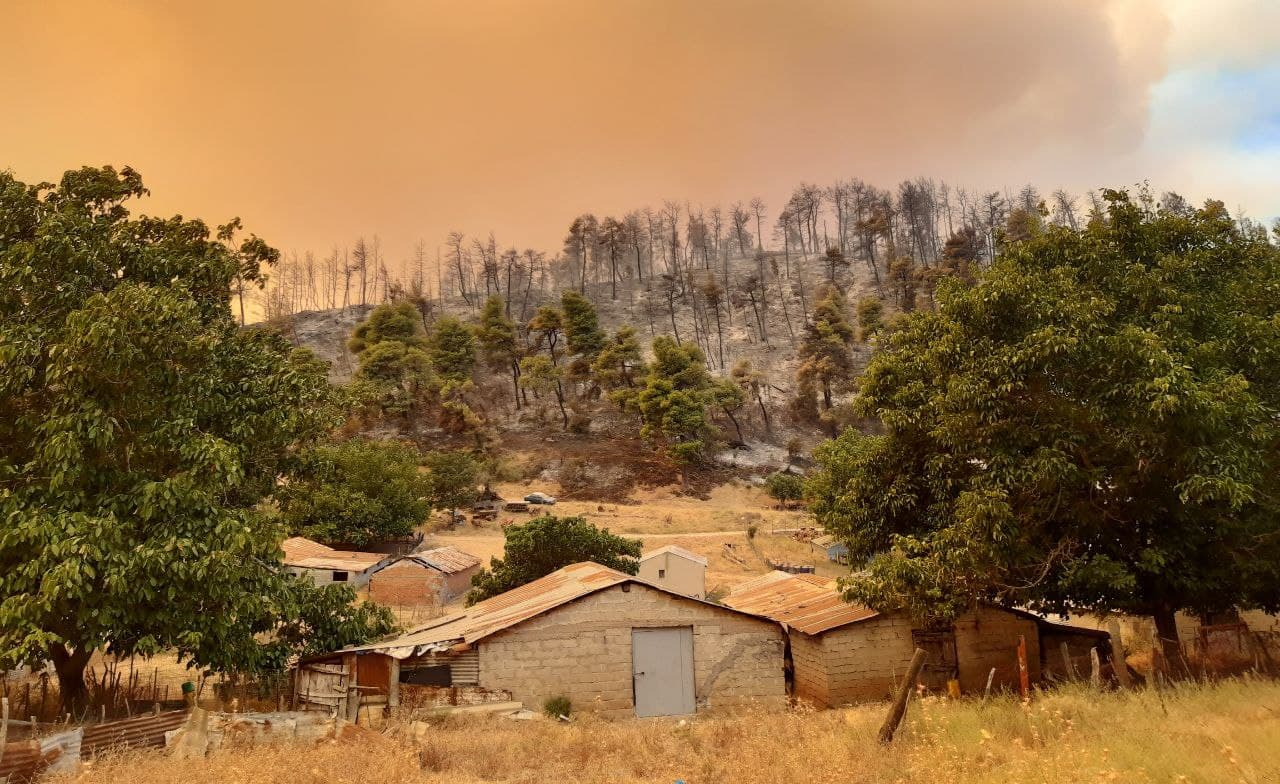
(296, 561, 786, 717)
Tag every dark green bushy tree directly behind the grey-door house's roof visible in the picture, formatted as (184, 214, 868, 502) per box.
(467, 515, 640, 605)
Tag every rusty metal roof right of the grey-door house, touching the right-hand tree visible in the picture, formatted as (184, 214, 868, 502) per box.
(724, 571, 879, 634)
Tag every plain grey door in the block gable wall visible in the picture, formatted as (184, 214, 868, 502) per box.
(631, 626, 694, 716)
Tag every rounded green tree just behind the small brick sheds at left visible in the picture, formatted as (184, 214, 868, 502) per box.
(275, 439, 431, 550)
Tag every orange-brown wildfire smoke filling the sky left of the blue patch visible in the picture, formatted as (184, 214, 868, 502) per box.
(0, 0, 1178, 260)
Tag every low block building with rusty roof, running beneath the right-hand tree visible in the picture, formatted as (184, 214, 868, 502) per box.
(724, 571, 1110, 707)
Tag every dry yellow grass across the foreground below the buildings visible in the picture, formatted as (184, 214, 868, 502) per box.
(63, 679, 1280, 784)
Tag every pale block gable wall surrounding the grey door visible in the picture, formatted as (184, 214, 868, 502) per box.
(477, 584, 786, 717)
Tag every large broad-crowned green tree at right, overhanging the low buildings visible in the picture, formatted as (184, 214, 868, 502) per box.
(808, 192, 1280, 661)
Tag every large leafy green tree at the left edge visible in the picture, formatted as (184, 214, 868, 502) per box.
(0, 168, 389, 710)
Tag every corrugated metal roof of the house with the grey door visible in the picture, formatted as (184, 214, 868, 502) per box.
(337, 561, 763, 658)
